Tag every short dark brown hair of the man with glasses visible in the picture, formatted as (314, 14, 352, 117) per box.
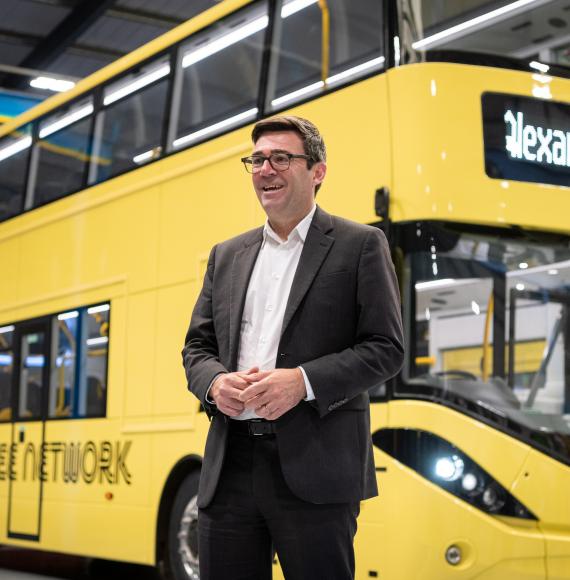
(251, 115, 327, 195)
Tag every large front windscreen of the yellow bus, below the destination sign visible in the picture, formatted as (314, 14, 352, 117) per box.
(399, 223, 570, 434)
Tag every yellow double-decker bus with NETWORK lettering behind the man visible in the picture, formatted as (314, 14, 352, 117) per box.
(0, 0, 570, 580)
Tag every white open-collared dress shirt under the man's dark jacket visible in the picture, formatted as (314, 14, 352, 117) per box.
(234, 206, 316, 420)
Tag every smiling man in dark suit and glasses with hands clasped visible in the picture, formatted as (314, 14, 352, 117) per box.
(182, 117, 403, 580)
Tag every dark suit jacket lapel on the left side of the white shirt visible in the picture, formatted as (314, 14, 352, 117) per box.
(229, 228, 263, 370)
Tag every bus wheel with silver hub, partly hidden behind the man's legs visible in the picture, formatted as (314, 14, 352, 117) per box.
(167, 471, 200, 580)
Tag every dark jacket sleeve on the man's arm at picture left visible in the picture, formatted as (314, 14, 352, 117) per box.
(182, 246, 228, 416)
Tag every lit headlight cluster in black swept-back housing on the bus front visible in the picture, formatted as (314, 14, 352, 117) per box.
(372, 429, 537, 520)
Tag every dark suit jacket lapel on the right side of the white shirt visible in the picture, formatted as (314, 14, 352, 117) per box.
(281, 207, 334, 336)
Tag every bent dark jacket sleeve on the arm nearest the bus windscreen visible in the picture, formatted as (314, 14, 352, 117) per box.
(302, 230, 404, 417)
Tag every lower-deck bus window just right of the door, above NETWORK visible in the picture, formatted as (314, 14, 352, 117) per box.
(48, 304, 109, 419)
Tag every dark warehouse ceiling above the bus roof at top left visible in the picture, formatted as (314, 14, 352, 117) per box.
(0, 0, 219, 96)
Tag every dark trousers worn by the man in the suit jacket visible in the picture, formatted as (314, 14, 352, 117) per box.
(198, 433, 360, 580)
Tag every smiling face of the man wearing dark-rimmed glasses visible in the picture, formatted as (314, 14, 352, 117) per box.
(252, 131, 326, 221)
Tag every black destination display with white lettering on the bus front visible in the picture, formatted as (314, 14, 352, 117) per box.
(481, 93, 570, 187)
